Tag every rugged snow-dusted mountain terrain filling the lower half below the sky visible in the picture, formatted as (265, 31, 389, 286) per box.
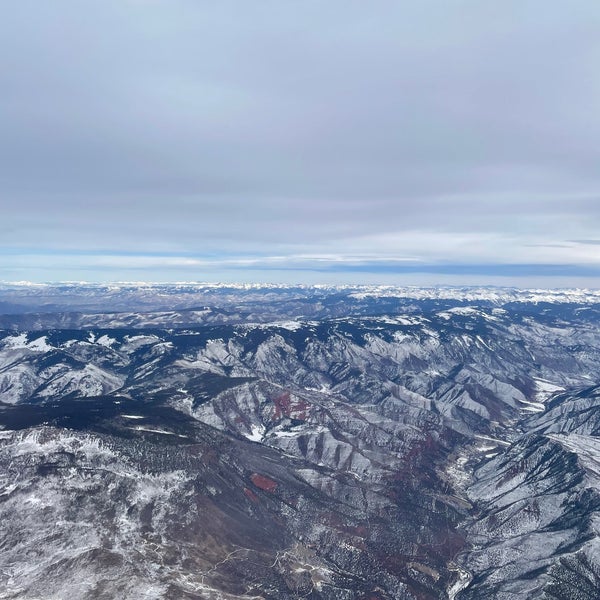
(0, 288, 600, 600)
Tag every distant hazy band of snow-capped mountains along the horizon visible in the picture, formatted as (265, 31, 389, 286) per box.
(0, 282, 600, 329)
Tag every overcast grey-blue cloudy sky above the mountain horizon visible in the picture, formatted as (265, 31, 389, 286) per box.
(0, 0, 600, 288)
